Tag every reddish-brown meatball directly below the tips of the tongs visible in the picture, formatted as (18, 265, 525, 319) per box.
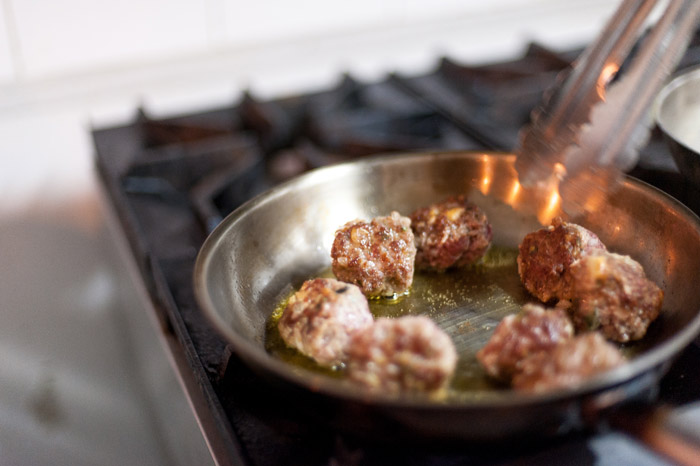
(518, 217, 606, 302)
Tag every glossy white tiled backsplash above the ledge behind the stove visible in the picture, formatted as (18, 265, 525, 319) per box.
(0, 0, 617, 85)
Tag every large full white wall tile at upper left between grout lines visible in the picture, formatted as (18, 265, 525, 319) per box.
(10, 0, 208, 80)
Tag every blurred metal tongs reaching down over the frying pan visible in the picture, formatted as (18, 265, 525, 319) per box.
(515, 0, 700, 213)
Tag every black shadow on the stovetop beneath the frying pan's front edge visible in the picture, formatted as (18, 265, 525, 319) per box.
(217, 355, 595, 466)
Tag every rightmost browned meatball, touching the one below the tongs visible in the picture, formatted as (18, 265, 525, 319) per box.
(571, 252, 664, 342)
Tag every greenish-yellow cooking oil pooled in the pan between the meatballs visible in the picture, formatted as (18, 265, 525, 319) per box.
(265, 246, 531, 392)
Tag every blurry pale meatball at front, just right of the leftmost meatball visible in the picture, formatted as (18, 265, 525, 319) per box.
(347, 316, 457, 393)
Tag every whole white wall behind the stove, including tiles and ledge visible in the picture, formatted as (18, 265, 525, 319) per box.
(0, 0, 619, 213)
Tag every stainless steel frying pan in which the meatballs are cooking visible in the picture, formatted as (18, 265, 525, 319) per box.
(194, 152, 700, 442)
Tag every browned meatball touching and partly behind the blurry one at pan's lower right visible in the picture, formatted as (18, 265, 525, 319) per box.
(476, 304, 574, 381)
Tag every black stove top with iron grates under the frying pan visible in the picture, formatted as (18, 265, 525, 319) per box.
(93, 36, 700, 465)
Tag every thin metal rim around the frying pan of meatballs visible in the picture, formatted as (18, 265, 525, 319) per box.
(193, 151, 700, 411)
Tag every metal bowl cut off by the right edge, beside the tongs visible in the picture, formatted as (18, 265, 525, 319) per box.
(656, 67, 700, 187)
